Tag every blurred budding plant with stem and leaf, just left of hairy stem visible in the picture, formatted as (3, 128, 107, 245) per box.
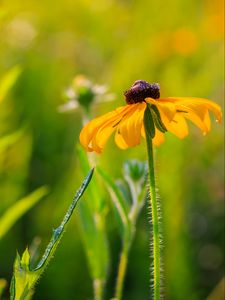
(98, 160, 146, 300)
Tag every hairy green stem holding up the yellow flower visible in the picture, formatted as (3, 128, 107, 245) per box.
(146, 132, 160, 300)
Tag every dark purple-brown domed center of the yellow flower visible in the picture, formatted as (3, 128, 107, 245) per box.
(124, 80, 160, 104)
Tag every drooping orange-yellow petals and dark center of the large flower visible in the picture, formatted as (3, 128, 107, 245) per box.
(80, 80, 222, 153)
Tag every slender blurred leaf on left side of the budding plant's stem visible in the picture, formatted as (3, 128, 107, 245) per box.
(97, 168, 130, 240)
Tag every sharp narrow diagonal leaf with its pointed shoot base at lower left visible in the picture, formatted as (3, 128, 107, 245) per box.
(10, 169, 94, 300)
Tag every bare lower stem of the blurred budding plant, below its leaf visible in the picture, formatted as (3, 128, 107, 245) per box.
(113, 245, 129, 300)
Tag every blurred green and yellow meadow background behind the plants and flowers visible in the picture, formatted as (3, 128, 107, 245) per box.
(0, 0, 224, 300)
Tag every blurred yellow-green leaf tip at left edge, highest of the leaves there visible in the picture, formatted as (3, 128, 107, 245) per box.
(0, 65, 22, 103)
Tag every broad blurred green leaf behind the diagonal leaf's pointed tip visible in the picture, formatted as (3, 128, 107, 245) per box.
(77, 146, 109, 285)
